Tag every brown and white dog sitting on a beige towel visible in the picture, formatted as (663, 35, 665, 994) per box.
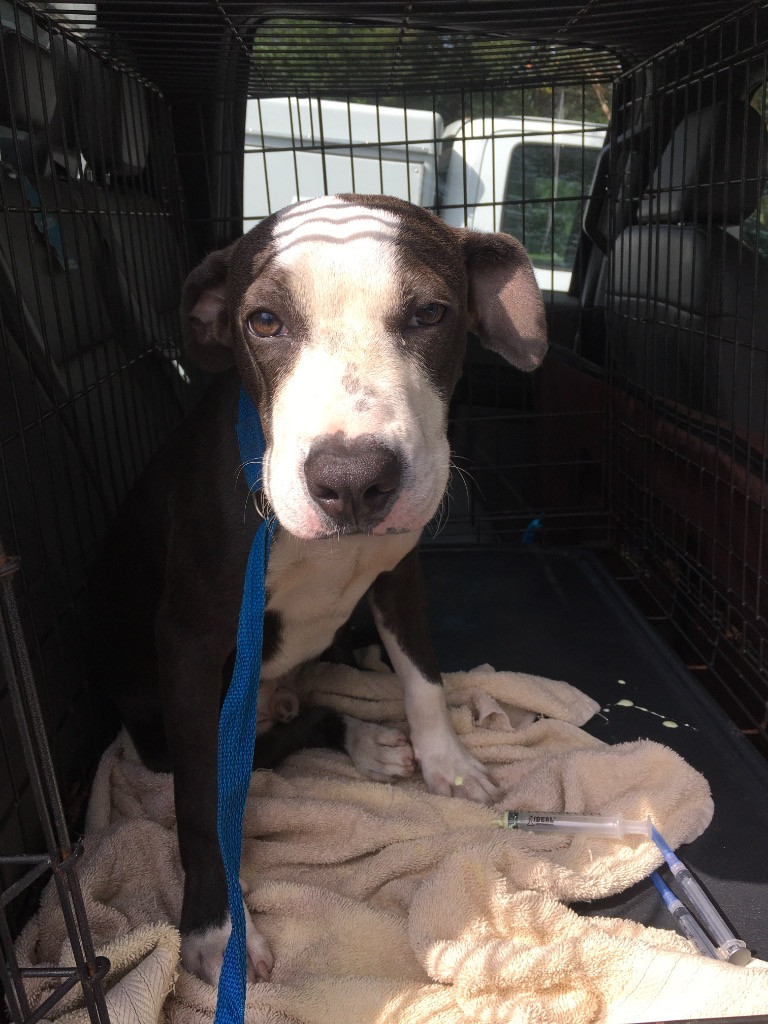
(88, 196, 547, 984)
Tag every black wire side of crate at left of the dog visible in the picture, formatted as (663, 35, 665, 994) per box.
(0, 0, 199, 1024)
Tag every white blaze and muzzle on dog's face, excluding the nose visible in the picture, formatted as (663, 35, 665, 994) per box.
(257, 199, 456, 538)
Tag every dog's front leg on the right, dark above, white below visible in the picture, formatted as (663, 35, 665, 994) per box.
(370, 549, 498, 803)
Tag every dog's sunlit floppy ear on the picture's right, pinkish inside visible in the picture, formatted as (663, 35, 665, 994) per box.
(462, 230, 548, 370)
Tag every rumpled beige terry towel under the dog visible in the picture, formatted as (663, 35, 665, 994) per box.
(13, 663, 768, 1024)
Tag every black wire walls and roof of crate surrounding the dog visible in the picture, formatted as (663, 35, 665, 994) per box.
(0, 0, 768, 1024)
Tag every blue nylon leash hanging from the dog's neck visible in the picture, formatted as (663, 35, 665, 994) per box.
(214, 388, 274, 1024)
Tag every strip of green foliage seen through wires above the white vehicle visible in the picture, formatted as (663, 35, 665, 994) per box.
(253, 18, 610, 124)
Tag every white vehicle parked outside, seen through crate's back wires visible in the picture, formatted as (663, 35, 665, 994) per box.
(243, 96, 605, 292)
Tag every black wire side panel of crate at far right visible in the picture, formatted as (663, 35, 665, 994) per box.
(607, 5, 768, 738)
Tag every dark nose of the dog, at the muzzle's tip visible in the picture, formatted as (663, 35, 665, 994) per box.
(304, 434, 402, 531)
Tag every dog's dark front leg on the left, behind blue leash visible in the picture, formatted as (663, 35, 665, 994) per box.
(157, 604, 272, 986)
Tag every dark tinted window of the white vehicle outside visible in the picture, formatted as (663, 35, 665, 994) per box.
(502, 141, 599, 290)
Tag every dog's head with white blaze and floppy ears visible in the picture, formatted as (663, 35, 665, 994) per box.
(181, 196, 547, 539)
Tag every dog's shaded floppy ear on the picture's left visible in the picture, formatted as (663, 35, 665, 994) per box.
(181, 244, 234, 373)
